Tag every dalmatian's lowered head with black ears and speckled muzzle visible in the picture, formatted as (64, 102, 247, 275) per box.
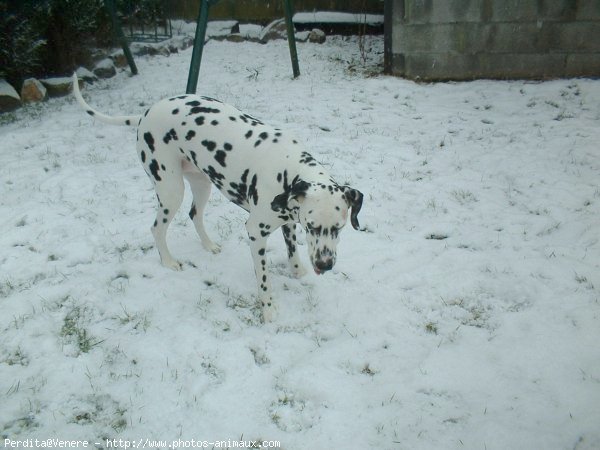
(271, 180, 363, 274)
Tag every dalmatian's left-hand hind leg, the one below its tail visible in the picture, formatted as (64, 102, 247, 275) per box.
(151, 169, 184, 270)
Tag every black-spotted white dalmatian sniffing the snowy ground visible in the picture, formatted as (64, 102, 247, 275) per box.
(73, 75, 363, 322)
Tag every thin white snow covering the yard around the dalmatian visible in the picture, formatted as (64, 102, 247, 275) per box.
(0, 33, 600, 450)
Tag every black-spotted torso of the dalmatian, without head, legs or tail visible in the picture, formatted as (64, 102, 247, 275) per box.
(137, 95, 329, 210)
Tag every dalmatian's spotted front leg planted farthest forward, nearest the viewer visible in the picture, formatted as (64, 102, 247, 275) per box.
(246, 217, 277, 322)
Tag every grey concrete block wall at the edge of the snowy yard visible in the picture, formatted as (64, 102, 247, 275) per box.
(385, 0, 600, 80)
